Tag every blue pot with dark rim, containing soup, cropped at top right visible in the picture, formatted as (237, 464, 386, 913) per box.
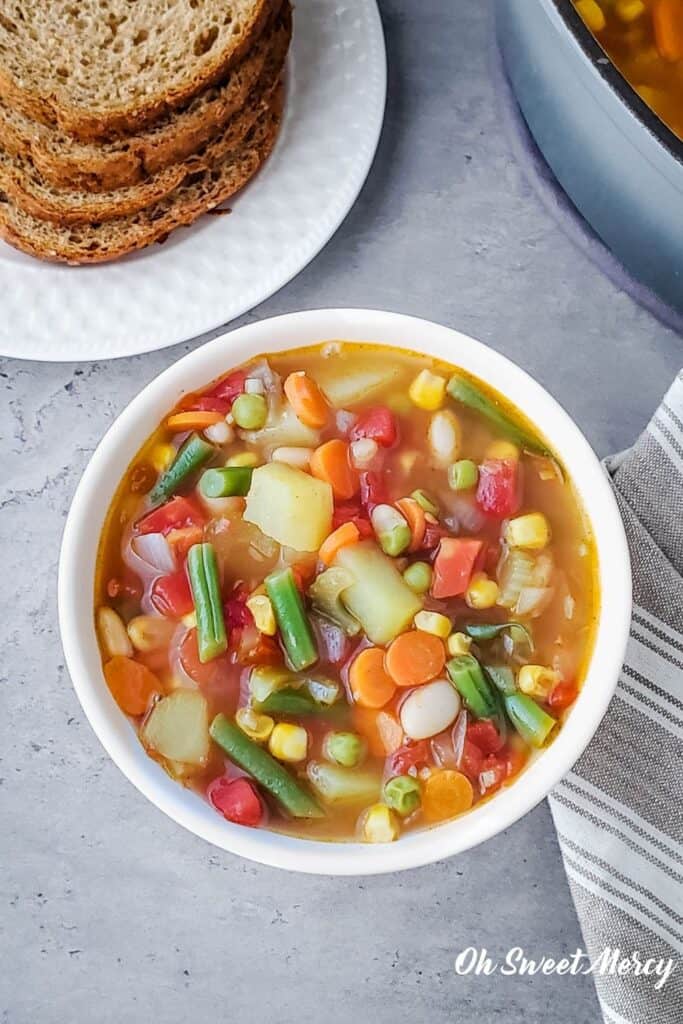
(495, 0, 683, 312)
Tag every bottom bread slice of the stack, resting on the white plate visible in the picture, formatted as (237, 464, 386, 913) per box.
(0, 87, 283, 264)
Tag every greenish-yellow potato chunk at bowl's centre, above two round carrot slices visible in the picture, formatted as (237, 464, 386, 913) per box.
(335, 541, 422, 645)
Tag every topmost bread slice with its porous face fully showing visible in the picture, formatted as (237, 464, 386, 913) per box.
(0, 0, 276, 141)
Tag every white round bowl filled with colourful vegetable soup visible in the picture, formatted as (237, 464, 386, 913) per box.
(59, 309, 631, 873)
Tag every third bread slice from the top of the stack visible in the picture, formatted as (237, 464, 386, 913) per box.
(0, 34, 282, 225)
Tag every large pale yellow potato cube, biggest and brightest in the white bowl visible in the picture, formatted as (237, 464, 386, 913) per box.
(244, 462, 333, 551)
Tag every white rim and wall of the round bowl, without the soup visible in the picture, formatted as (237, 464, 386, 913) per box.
(58, 309, 631, 874)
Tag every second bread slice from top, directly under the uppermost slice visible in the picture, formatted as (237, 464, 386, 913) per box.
(0, 0, 292, 191)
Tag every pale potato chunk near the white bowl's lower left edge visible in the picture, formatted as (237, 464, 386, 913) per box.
(140, 689, 209, 765)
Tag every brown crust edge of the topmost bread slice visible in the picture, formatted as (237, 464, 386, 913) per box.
(0, 0, 279, 142)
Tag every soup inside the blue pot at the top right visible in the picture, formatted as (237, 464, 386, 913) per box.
(573, 0, 683, 139)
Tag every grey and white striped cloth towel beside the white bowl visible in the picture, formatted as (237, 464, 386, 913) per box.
(550, 371, 683, 1024)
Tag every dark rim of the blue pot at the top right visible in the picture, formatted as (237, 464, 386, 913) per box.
(549, 0, 683, 164)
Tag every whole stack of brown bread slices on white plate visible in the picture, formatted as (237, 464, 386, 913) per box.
(0, 0, 292, 264)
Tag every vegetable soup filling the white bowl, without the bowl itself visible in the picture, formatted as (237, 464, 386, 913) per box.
(95, 342, 597, 843)
